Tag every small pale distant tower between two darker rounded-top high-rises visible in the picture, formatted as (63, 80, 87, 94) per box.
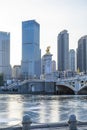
(69, 49, 75, 71)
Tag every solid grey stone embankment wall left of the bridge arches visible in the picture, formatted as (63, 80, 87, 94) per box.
(0, 80, 56, 94)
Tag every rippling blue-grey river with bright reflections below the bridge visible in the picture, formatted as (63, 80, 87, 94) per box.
(0, 94, 87, 127)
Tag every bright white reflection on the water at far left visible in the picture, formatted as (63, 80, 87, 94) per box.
(8, 95, 23, 126)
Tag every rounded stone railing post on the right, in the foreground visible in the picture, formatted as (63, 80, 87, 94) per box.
(68, 115, 77, 130)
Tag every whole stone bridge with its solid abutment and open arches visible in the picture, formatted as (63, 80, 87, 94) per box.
(1, 75, 87, 95)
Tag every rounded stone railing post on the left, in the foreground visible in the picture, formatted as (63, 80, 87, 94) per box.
(22, 115, 32, 130)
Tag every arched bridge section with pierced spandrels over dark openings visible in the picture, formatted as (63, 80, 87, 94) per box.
(56, 75, 87, 94)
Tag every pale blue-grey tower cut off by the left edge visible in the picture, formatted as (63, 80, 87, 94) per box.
(0, 32, 11, 79)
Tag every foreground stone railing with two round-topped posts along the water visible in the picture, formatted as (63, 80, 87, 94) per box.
(0, 115, 87, 130)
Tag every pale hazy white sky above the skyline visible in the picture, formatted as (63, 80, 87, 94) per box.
(0, 0, 87, 66)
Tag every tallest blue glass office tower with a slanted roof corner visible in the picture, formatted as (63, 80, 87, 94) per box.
(21, 20, 41, 78)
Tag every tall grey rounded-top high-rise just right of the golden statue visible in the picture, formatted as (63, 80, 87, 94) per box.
(57, 30, 69, 71)
